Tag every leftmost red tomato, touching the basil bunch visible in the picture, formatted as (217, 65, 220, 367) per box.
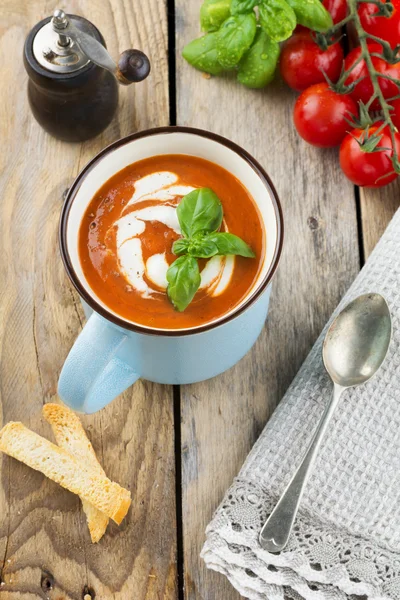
(280, 32, 343, 92)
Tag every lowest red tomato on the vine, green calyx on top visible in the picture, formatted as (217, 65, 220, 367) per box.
(340, 123, 400, 187)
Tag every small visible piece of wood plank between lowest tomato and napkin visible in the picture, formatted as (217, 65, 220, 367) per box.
(360, 181, 400, 258)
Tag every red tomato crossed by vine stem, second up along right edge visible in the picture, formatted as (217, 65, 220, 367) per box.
(344, 42, 400, 110)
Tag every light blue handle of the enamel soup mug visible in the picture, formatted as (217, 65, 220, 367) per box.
(58, 313, 140, 414)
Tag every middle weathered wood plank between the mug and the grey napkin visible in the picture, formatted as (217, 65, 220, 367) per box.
(176, 0, 359, 600)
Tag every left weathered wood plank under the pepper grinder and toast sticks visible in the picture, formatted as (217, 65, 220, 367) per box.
(0, 0, 177, 600)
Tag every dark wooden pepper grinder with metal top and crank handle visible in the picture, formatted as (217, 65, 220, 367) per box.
(24, 10, 150, 142)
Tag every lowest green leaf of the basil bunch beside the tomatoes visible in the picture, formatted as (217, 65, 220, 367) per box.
(237, 27, 280, 88)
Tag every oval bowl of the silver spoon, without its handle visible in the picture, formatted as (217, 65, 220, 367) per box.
(322, 294, 392, 388)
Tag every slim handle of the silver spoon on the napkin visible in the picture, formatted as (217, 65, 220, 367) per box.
(259, 384, 345, 552)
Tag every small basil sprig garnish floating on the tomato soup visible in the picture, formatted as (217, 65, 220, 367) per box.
(167, 188, 255, 312)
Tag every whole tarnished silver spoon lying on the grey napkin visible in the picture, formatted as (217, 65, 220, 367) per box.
(259, 294, 392, 552)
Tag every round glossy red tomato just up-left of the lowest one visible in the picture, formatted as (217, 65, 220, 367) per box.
(293, 83, 357, 148)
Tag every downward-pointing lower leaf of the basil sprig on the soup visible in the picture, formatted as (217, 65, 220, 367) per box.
(167, 254, 201, 312)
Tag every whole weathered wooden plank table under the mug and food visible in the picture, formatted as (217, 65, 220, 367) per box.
(0, 0, 400, 600)
